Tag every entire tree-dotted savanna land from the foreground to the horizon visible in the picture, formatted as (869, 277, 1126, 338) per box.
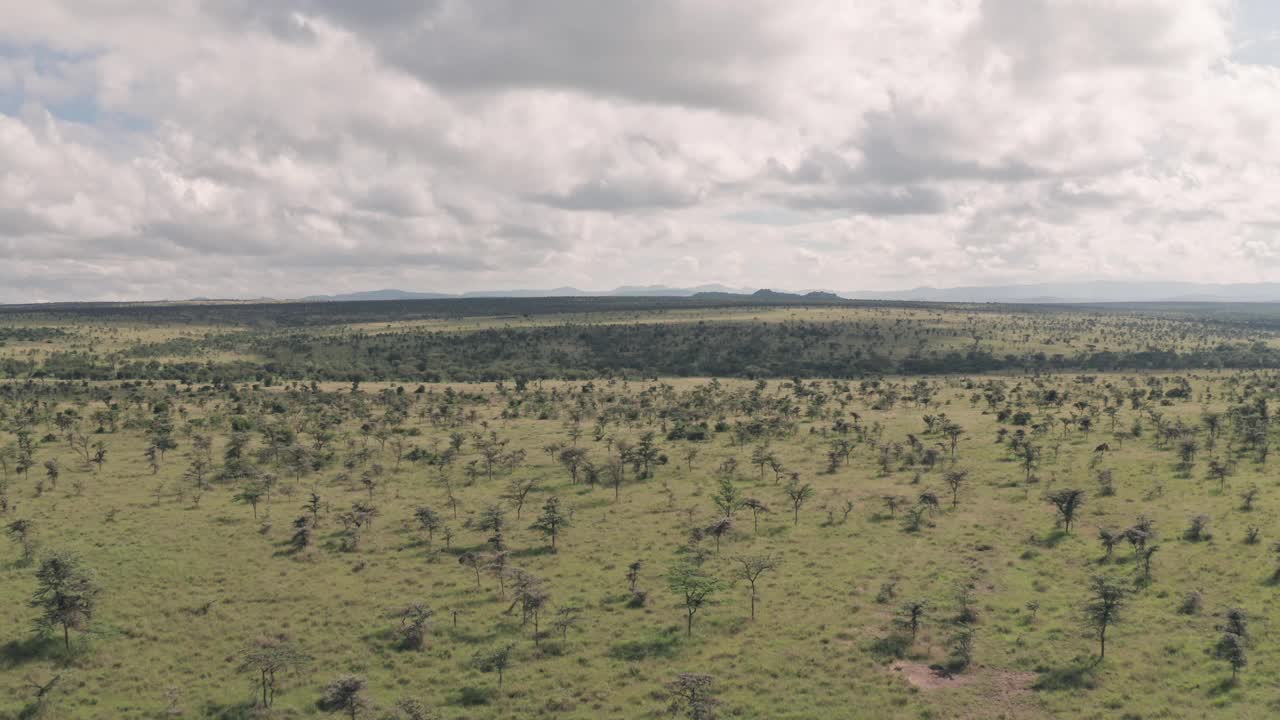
(0, 299, 1280, 719)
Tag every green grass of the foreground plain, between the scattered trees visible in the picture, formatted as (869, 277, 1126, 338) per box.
(0, 310, 1280, 719)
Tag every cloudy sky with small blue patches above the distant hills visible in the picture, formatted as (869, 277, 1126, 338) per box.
(0, 0, 1280, 302)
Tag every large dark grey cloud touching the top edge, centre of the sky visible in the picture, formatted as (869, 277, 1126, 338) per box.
(308, 0, 790, 110)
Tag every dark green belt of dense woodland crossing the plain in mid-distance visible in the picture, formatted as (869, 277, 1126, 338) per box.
(0, 322, 1280, 383)
